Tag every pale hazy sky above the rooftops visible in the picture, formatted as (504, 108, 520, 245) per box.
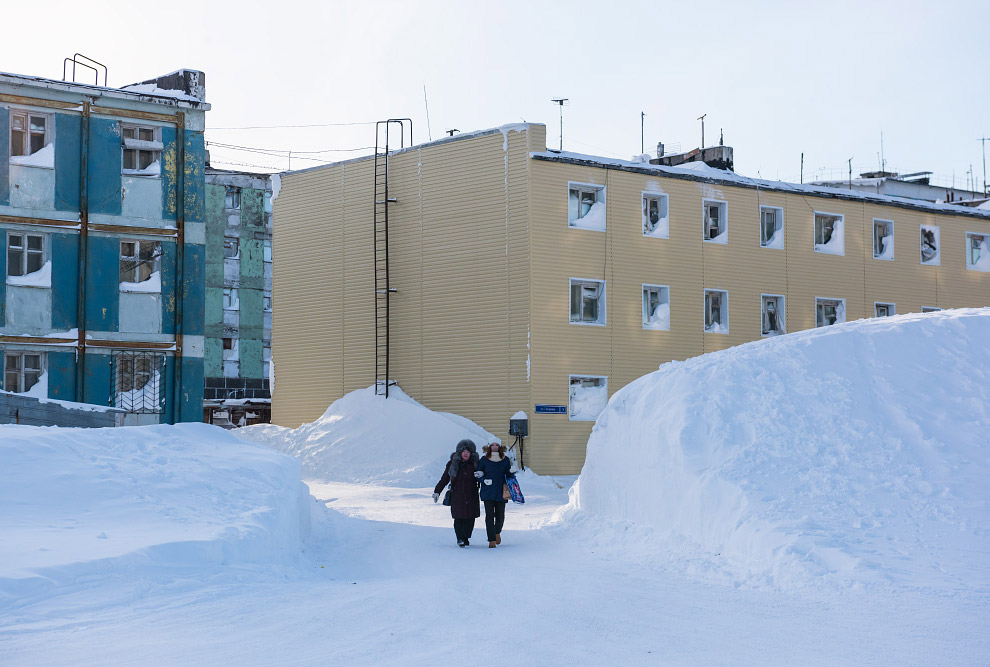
(7, 0, 990, 186)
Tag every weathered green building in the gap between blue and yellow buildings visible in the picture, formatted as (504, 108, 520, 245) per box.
(203, 167, 272, 426)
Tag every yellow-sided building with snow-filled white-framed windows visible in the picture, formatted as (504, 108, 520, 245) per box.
(272, 124, 990, 474)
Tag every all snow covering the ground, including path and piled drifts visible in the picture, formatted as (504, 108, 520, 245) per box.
(0, 310, 990, 665)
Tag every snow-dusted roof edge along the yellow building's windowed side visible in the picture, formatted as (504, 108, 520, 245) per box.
(530, 151, 990, 220)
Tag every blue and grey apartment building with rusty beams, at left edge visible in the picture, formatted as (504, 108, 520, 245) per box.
(0, 70, 210, 424)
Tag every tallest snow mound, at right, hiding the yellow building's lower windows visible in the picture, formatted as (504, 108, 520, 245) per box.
(560, 309, 990, 591)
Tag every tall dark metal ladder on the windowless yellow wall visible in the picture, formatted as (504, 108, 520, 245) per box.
(374, 118, 412, 398)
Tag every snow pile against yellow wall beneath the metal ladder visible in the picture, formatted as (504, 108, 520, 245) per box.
(234, 387, 501, 488)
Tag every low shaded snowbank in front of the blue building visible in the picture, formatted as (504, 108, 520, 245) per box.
(0, 424, 313, 589)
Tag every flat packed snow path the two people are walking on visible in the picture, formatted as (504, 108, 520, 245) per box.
(0, 483, 990, 666)
